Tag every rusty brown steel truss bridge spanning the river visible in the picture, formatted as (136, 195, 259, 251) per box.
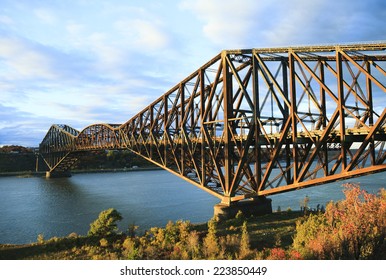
(39, 42, 386, 205)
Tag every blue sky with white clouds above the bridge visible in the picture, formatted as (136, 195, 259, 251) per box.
(0, 0, 386, 147)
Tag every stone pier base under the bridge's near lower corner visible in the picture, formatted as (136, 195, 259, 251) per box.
(214, 198, 272, 220)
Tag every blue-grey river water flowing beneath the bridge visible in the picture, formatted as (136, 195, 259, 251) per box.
(0, 170, 386, 244)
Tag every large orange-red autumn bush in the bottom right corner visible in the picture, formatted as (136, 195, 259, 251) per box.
(293, 184, 386, 259)
